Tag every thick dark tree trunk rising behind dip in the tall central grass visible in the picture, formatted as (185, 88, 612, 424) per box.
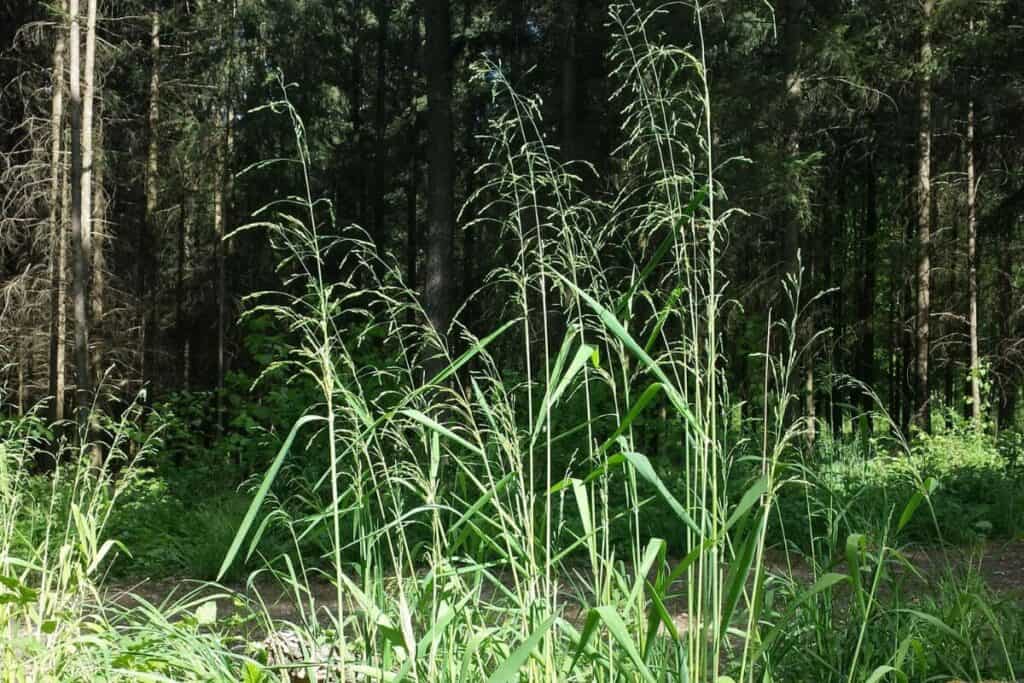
(424, 0, 455, 336)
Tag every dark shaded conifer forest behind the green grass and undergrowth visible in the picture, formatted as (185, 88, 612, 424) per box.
(0, 0, 1024, 438)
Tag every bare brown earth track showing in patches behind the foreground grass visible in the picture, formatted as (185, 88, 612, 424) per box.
(103, 540, 1024, 630)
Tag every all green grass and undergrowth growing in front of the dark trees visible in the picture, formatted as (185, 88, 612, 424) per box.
(0, 7, 1024, 683)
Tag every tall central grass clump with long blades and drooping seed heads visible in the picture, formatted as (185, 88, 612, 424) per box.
(216, 6, 806, 681)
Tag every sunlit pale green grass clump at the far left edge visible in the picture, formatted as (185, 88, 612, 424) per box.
(0, 395, 148, 681)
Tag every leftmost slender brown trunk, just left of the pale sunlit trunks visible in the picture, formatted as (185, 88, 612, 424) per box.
(49, 18, 68, 422)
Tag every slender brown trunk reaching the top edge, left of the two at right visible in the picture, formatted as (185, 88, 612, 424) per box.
(913, 0, 935, 431)
